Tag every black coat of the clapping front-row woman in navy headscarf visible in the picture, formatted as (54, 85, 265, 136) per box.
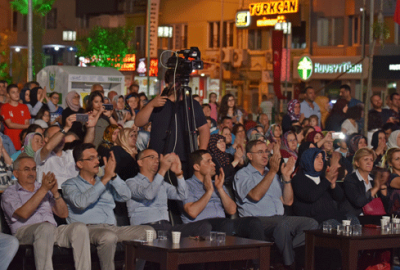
(292, 170, 346, 223)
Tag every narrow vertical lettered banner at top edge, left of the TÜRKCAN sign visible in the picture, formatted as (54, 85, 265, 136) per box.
(146, 0, 160, 58)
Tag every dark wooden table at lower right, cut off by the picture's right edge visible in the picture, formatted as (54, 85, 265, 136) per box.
(305, 228, 400, 270)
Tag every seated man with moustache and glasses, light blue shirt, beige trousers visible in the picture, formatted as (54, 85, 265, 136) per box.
(61, 143, 154, 270)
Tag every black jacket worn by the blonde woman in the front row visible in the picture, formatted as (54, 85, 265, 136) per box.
(341, 172, 374, 216)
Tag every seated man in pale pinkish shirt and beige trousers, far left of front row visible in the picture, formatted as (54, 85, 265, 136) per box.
(0, 154, 91, 270)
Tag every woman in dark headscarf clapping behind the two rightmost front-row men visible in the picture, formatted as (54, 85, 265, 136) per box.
(208, 134, 243, 198)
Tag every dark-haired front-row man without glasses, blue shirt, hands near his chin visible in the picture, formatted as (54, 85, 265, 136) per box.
(182, 150, 264, 240)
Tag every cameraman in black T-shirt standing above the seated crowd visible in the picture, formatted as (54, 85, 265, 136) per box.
(135, 69, 210, 178)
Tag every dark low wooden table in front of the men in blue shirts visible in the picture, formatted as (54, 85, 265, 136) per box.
(124, 236, 273, 270)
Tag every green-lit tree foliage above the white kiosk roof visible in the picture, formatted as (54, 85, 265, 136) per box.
(76, 26, 134, 67)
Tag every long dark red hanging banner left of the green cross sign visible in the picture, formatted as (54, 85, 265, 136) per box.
(272, 30, 286, 99)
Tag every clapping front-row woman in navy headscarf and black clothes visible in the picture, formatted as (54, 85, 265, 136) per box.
(292, 148, 360, 228)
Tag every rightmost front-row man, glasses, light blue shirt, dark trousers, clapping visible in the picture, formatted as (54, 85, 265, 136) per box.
(233, 141, 318, 267)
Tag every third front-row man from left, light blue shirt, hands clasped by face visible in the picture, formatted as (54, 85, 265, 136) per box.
(126, 149, 211, 237)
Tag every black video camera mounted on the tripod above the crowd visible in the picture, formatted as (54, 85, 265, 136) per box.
(167, 47, 204, 85)
